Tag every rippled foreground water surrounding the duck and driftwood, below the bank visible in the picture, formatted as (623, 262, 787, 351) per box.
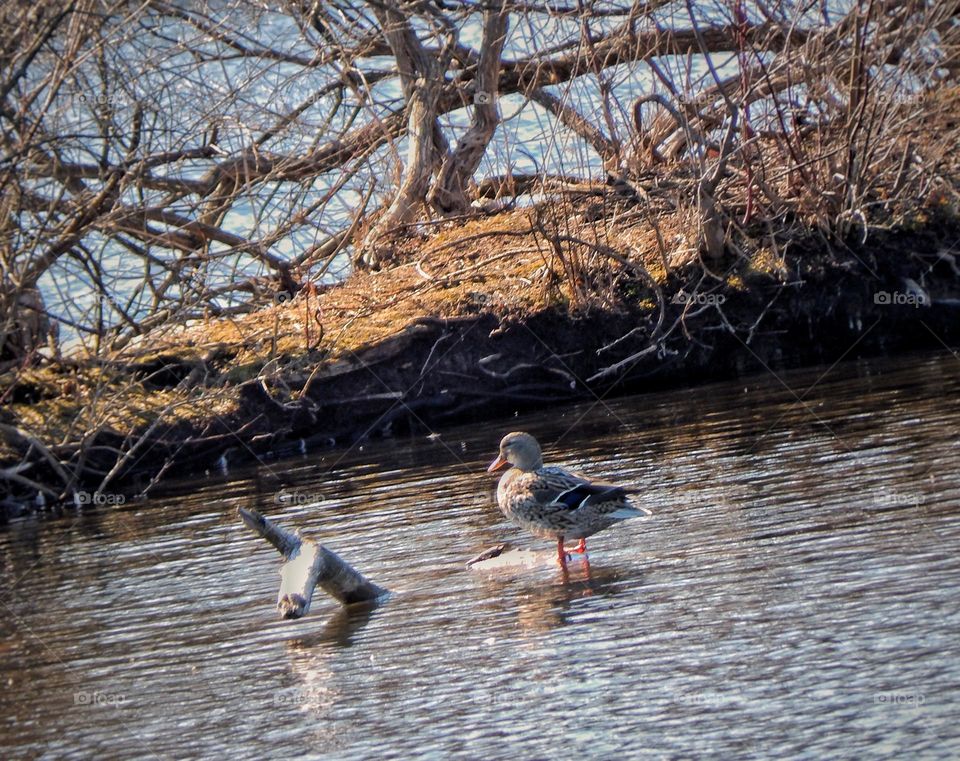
(0, 355, 960, 759)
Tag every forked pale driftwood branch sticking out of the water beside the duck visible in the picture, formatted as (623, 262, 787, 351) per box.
(237, 507, 386, 618)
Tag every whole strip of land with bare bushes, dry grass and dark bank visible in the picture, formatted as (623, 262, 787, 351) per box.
(0, 3, 960, 514)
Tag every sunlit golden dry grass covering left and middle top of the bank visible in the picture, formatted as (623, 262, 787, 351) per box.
(0, 197, 692, 470)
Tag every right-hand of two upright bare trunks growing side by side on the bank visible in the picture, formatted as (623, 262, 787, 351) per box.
(427, 2, 510, 214)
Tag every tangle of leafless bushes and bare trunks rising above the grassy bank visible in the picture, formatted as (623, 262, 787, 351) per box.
(0, 0, 960, 508)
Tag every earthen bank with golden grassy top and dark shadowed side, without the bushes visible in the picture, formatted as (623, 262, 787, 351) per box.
(0, 196, 960, 513)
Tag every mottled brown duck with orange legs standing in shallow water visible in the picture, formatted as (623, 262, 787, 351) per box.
(487, 431, 650, 568)
